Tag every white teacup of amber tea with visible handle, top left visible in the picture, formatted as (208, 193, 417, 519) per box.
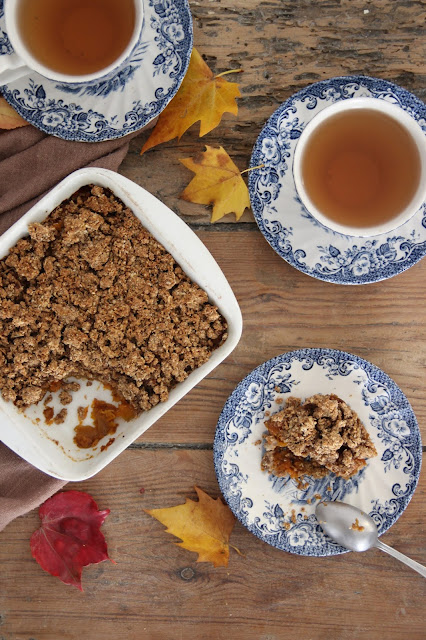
(0, 0, 143, 85)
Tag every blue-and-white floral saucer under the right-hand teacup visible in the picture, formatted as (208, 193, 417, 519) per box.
(249, 76, 426, 284)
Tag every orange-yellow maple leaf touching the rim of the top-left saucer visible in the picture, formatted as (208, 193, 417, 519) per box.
(141, 49, 241, 155)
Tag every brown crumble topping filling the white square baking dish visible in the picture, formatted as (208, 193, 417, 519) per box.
(0, 185, 227, 436)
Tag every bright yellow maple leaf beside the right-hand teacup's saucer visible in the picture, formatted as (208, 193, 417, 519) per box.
(180, 145, 250, 222)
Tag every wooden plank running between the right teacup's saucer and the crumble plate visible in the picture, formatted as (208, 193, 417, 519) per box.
(141, 231, 426, 443)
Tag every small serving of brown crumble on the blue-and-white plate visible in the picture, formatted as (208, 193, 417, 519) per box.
(261, 394, 377, 479)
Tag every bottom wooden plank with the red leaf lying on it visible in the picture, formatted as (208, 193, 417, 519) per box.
(0, 451, 426, 640)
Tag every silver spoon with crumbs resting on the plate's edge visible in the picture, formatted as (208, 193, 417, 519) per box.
(315, 501, 426, 578)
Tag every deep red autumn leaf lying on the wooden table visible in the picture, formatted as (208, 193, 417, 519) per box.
(30, 491, 110, 591)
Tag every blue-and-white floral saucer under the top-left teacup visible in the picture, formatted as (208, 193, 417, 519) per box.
(0, 0, 193, 142)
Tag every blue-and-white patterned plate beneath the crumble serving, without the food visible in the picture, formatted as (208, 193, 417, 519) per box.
(213, 349, 422, 556)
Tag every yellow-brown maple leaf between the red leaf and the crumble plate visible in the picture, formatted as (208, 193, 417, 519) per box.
(144, 487, 235, 567)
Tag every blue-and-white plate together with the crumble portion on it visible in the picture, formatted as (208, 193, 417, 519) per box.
(214, 349, 421, 556)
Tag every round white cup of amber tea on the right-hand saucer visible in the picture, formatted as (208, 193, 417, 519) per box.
(293, 98, 426, 237)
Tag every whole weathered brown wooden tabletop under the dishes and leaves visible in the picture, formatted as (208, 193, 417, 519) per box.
(0, 0, 426, 640)
